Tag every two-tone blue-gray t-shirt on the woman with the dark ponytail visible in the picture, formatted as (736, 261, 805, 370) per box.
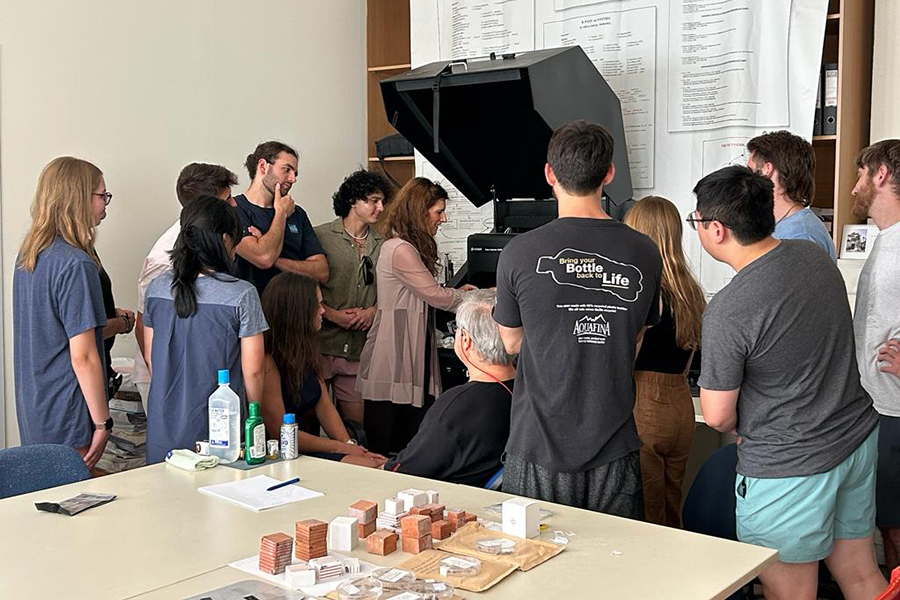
(144, 271, 269, 464)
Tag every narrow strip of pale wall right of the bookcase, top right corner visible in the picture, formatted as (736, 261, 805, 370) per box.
(871, 0, 900, 142)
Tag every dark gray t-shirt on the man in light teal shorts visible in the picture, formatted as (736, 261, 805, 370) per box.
(699, 240, 877, 478)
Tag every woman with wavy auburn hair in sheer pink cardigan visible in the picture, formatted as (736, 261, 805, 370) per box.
(356, 177, 474, 454)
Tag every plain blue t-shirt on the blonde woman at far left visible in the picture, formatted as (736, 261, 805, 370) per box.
(13, 238, 106, 448)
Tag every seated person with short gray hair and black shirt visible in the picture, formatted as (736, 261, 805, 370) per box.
(383, 290, 516, 487)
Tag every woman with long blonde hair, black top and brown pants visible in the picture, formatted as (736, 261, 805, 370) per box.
(625, 196, 706, 527)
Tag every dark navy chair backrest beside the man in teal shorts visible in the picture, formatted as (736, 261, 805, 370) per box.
(681, 444, 737, 540)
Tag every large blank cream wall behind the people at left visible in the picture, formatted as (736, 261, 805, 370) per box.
(0, 0, 365, 446)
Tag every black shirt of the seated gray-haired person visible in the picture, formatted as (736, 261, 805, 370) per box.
(384, 381, 513, 487)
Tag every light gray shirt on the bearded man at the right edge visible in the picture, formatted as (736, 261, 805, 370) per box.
(853, 223, 900, 417)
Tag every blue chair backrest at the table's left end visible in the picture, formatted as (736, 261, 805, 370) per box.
(0, 444, 91, 498)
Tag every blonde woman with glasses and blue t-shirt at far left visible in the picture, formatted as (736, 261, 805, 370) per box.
(13, 156, 112, 467)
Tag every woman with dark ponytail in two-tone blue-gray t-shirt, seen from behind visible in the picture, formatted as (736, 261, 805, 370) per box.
(144, 196, 268, 464)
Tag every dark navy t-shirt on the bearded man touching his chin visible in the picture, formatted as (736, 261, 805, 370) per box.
(234, 194, 325, 295)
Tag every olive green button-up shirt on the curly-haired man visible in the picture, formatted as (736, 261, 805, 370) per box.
(315, 217, 384, 361)
